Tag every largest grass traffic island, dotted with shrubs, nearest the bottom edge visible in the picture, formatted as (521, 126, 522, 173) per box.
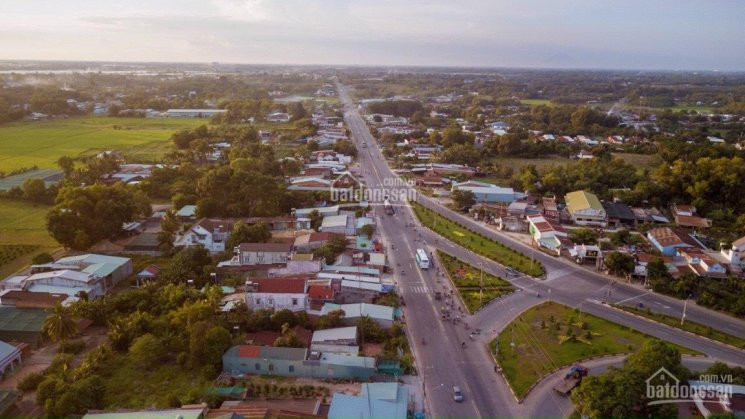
(490, 302, 696, 398)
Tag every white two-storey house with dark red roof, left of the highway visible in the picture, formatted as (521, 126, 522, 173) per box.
(246, 276, 308, 311)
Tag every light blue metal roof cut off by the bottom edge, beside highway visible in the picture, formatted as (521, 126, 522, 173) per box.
(328, 382, 409, 419)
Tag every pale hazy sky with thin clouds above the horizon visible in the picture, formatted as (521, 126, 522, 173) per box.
(0, 0, 745, 71)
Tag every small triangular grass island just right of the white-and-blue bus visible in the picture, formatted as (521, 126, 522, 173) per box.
(437, 250, 515, 314)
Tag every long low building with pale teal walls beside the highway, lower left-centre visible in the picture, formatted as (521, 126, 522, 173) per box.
(222, 345, 377, 381)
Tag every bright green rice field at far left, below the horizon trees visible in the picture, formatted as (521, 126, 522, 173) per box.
(0, 117, 209, 171)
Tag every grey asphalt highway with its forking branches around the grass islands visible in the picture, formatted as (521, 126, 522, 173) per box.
(337, 85, 745, 417)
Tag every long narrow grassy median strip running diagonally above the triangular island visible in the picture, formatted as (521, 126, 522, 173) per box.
(411, 202, 544, 276)
